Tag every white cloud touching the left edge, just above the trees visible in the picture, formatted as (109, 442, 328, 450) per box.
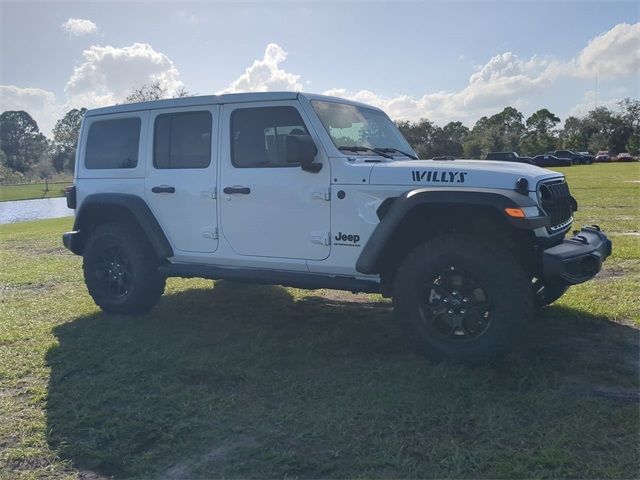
(0, 85, 62, 135)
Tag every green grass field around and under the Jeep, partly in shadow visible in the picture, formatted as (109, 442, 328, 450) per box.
(0, 164, 640, 479)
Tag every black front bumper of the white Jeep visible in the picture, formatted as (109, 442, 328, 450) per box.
(542, 225, 611, 285)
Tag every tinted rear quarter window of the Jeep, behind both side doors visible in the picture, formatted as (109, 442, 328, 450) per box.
(84, 117, 141, 169)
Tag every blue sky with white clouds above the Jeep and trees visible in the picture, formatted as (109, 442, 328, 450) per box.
(0, 1, 640, 133)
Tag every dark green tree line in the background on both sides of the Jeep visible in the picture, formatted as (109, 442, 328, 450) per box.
(0, 82, 640, 183)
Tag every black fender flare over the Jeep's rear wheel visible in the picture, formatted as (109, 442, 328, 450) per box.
(71, 193, 173, 258)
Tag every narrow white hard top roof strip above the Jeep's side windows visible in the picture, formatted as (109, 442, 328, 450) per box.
(86, 92, 379, 117)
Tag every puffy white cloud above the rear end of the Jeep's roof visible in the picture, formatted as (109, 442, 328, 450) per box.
(64, 43, 183, 108)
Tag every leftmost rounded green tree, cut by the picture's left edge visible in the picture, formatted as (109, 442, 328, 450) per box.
(0, 110, 49, 173)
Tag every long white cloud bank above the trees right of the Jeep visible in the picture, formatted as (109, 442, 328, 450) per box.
(324, 23, 640, 125)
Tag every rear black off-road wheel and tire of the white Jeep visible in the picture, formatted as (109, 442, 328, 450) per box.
(82, 223, 165, 314)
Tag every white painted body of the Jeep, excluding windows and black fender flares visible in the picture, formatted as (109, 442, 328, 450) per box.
(75, 93, 562, 281)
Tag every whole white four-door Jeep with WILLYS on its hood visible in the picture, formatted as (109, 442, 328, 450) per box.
(63, 92, 611, 361)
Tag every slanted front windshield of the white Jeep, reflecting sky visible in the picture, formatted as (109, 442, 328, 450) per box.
(311, 100, 415, 156)
